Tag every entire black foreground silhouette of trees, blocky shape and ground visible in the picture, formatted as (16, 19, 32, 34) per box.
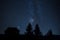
(0, 23, 60, 40)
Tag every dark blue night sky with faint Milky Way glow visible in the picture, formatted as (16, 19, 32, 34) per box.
(0, 0, 60, 35)
